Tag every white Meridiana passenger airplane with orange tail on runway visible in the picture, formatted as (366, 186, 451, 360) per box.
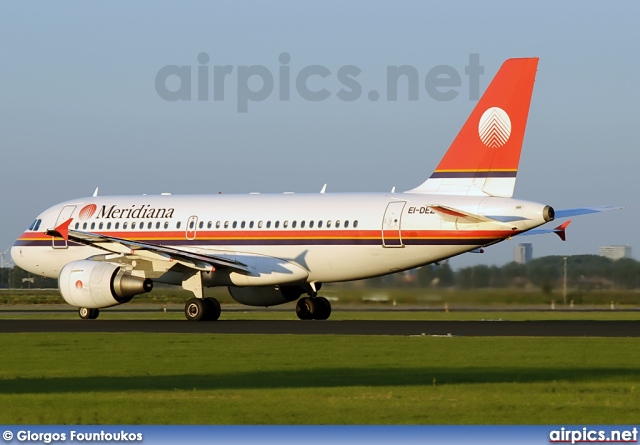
(11, 58, 613, 321)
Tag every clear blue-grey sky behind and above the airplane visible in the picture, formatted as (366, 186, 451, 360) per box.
(0, 1, 640, 267)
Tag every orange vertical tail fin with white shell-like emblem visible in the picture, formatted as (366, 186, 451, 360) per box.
(408, 58, 538, 197)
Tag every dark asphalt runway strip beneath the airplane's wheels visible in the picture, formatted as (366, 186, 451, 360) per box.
(0, 319, 640, 337)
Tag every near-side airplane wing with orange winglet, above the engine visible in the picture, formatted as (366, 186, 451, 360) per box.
(45, 218, 250, 272)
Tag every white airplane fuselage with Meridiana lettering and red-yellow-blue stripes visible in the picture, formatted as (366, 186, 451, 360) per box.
(11, 193, 546, 286)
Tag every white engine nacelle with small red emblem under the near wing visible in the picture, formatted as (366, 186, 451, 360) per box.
(58, 260, 153, 309)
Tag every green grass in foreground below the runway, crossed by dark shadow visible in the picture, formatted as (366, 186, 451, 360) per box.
(0, 333, 640, 424)
